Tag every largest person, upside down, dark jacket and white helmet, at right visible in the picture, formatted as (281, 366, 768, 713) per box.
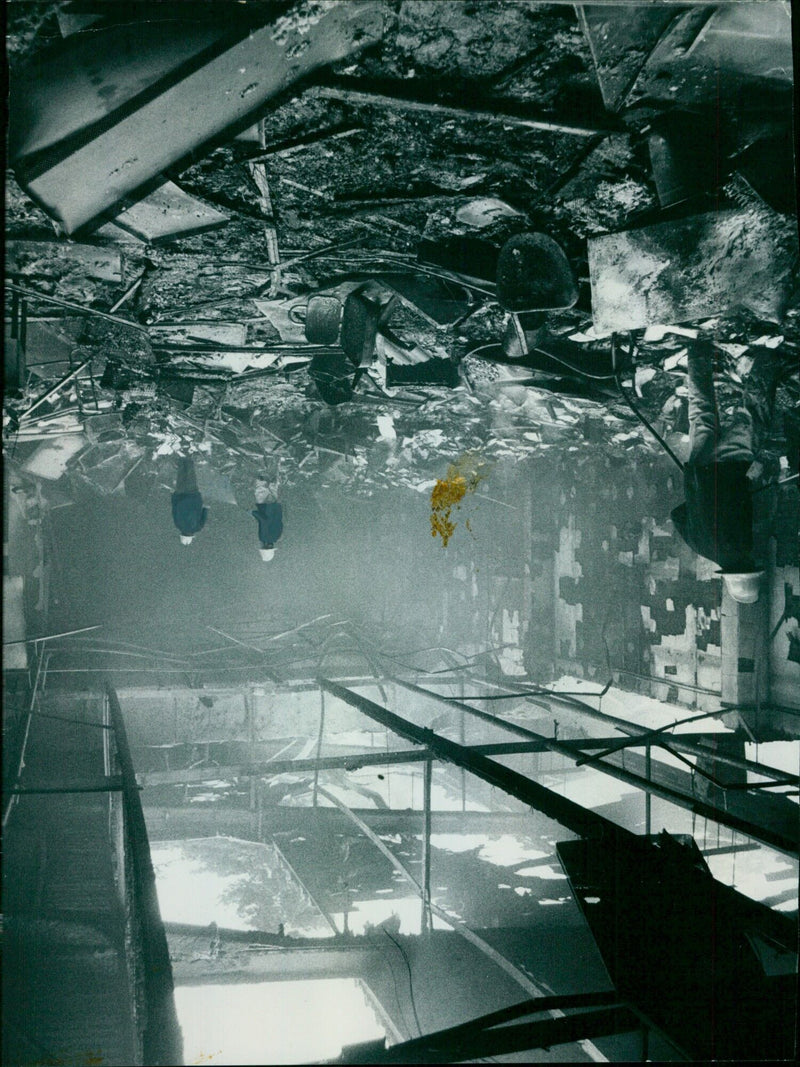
(672, 340, 775, 604)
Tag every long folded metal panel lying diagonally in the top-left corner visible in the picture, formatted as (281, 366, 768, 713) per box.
(11, 3, 383, 234)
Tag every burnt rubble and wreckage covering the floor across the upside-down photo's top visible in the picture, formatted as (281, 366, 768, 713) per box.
(5, 3, 797, 510)
